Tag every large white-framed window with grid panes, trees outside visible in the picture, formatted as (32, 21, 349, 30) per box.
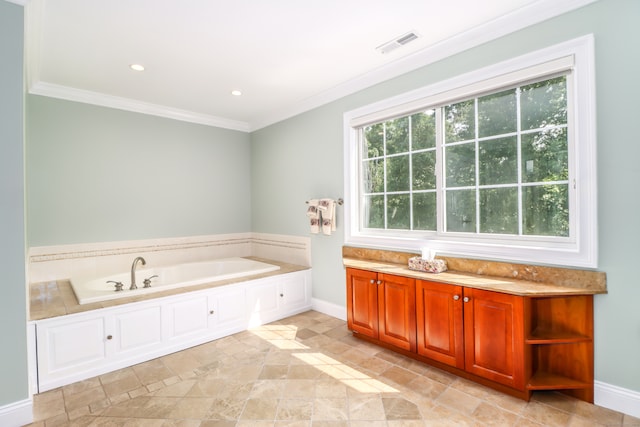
(345, 37, 597, 267)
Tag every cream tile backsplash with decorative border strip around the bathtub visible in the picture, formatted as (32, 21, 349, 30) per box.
(28, 233, 311, 283)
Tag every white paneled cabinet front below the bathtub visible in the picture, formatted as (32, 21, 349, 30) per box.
(33, 270, 311, 392)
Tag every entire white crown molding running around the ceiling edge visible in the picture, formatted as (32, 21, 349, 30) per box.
(23, 0, 598, 132)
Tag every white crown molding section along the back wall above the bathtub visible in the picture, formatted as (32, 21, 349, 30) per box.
(29, 82, 249, 132)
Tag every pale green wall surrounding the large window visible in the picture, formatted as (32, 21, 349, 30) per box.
(251, 0, 640, 391)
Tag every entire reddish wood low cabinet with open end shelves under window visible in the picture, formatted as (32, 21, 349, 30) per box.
(347, 268, 593, 402)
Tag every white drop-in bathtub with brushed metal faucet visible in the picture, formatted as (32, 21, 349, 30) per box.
(71, 257, 280, 304)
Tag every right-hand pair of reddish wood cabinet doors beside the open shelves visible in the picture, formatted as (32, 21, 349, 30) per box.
(416, 280, 525, 390)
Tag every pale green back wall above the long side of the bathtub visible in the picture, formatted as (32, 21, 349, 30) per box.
(26, 95, 251, 246)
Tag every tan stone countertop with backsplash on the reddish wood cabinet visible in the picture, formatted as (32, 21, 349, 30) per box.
(343, 247, 607, 297)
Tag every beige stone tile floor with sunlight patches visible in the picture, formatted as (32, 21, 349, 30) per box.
(30, 311, 640, 427)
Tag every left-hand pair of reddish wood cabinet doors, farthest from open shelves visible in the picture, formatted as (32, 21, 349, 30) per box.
(347, 268, 416, 352)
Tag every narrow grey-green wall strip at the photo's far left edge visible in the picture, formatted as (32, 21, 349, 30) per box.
(0, 1, 29, 407)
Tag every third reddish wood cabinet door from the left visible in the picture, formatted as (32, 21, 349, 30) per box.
(416, 280, 464, 369)
